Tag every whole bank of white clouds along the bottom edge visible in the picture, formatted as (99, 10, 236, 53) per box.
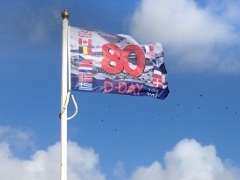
(0, 127, 240, 180)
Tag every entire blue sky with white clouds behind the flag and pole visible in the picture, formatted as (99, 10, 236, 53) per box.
(0, 0, 240, 180)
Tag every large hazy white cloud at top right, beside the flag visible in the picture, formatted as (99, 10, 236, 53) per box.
(131, 0, 240, 73)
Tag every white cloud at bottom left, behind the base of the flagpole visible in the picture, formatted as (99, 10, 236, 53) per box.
(0, 142, 105, 180)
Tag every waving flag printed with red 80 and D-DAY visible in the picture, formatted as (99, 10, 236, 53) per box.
(69, 27, 170, 99)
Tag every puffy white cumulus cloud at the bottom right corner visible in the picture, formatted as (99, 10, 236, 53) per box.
(130, 139, 240, 180)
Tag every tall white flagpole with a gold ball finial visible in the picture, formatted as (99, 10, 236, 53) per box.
(60, 10, 69, 180)
